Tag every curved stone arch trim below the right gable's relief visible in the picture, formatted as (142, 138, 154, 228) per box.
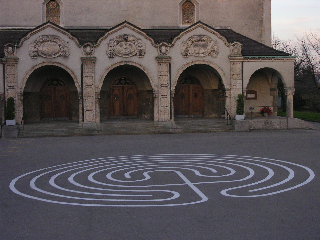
(171, 60, 229, 92)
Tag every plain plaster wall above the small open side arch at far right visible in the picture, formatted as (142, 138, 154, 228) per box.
(243, 58, 294, 88)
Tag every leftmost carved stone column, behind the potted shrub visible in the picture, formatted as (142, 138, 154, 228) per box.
(2, 57, 23, 124)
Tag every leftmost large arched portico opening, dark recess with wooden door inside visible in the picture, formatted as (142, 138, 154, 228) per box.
(19, 64, 80, 123)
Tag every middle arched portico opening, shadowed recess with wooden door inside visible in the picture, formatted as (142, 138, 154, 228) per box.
(99, 64, 154, 121)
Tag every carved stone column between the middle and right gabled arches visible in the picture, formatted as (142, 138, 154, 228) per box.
(154, 56, 171, 122)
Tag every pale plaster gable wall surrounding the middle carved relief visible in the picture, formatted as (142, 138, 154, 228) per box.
(94, 28, 158, 90)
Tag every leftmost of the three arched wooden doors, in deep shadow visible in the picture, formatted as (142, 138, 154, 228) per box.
(40, 79, 70, 119)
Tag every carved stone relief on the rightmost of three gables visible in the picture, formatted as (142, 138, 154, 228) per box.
(181, 35, 219, 57)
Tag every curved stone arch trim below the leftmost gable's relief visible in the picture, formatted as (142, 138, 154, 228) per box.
(19, 62, 81, 93)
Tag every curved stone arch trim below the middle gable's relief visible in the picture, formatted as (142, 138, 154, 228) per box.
(97, 61, 157, 91)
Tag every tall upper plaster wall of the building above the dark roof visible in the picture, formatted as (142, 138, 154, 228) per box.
(0, 0, 271, 45)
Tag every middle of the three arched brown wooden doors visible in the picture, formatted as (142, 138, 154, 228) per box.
(110, 77, 139, 117)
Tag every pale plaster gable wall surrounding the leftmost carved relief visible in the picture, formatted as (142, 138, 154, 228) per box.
(16, 27, 82, 91)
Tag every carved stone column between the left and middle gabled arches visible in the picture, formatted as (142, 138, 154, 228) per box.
(81, 57, 97, 124)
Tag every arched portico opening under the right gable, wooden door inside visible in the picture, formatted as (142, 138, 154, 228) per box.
(173, 61, 226, 117)
